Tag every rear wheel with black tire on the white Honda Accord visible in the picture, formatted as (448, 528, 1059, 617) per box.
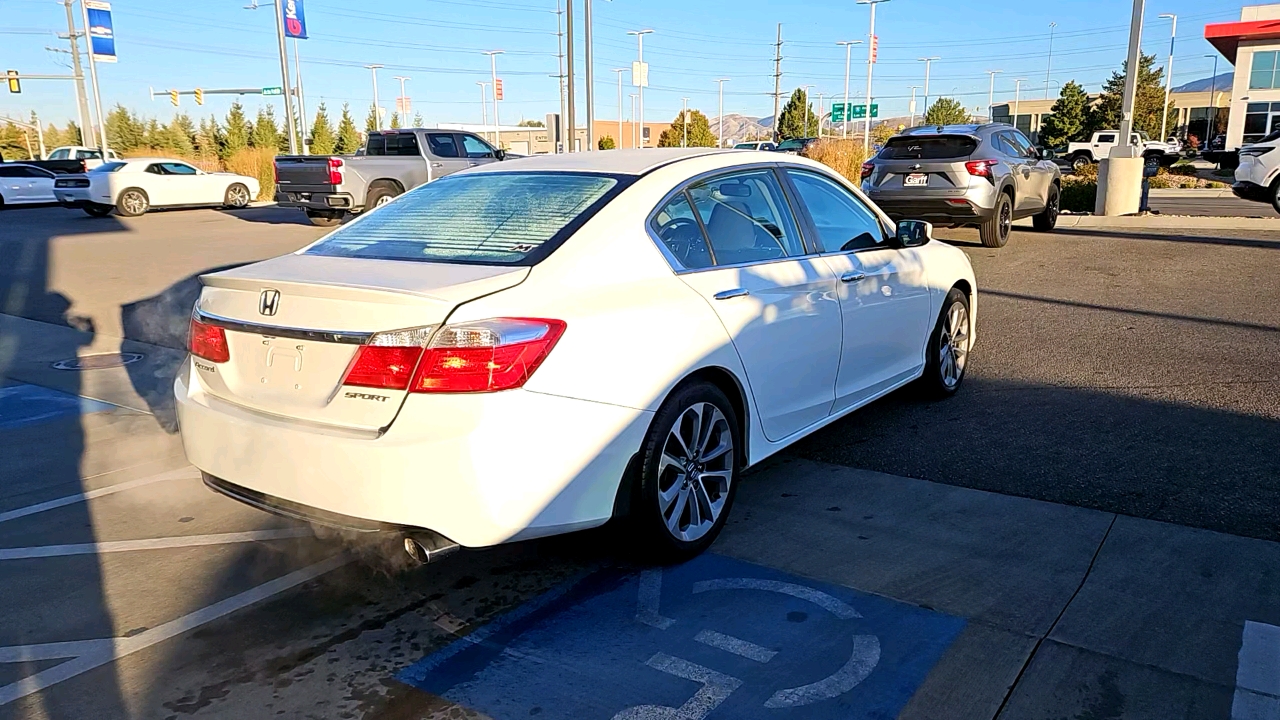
(630, 382, 742, 564)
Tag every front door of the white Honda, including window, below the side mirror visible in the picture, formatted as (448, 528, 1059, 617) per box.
(786, 168, 933, 411)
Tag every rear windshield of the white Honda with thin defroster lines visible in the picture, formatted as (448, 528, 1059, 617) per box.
(306, 172, 626, 265)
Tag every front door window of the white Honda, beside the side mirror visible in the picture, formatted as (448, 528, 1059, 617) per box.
(787, 169, 886, 252)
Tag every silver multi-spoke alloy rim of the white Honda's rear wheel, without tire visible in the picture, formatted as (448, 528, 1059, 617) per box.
(658, 402, 733, 542)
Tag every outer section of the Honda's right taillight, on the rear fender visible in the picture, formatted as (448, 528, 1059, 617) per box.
(410, 318, 564, 392)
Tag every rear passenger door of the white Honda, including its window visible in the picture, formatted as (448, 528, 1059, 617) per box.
(652, 168, 841, 441)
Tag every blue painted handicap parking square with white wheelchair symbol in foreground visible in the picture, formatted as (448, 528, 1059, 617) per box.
(398, 555, 965, 720)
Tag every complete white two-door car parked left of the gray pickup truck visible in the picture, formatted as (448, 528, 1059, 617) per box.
(54, 158, 260, 218)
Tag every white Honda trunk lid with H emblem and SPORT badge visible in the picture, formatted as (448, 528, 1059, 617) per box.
(196, 255, 529, 430)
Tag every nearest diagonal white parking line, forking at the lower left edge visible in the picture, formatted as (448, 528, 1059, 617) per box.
(0, 555, 351, 705)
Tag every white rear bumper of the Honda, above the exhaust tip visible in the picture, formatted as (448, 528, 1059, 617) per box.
(174, 363, 653, 547)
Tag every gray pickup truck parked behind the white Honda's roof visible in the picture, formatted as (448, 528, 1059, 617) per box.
(275, 128, 507, 225)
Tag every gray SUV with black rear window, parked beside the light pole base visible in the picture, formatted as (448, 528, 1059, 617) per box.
(863, 123, 1062, 247)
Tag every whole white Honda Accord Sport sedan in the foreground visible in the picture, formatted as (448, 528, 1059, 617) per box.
(174, 150, 977, 559)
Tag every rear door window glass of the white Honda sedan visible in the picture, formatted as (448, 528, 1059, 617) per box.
(689, 170, 805, 265)
